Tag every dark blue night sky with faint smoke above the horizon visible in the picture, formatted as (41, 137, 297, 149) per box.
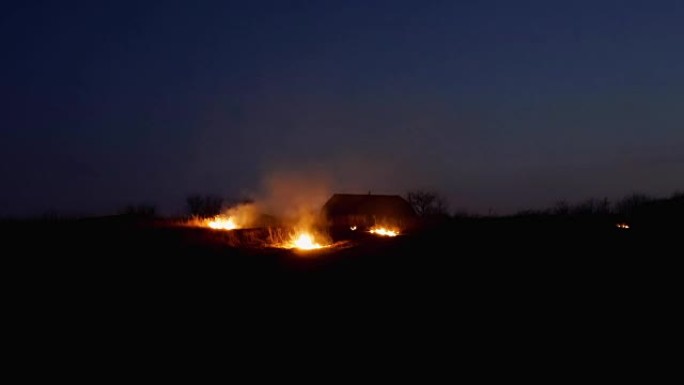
(0, 0, 684, 216)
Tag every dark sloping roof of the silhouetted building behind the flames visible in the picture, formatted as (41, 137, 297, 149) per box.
(323, 194, 416, 218)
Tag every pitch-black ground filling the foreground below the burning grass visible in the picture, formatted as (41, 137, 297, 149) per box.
(3, 218, 682, 376)
